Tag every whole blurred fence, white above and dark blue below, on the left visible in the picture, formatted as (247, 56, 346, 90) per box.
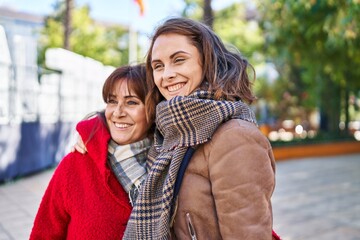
(0, 49, 114, 182)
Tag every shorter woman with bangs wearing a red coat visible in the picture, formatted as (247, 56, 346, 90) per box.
(30, 65, 152, 240)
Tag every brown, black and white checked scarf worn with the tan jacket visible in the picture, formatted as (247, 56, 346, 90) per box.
(124, 90, 256, 239)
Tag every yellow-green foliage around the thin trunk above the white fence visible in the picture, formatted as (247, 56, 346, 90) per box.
(39, 2, 129, 66)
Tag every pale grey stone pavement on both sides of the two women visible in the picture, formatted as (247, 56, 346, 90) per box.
(0, 154, 360, 240)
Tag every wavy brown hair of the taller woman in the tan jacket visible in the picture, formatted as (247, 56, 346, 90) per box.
(146, 18, 255, 122)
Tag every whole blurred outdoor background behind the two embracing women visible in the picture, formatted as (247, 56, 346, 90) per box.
(0, 0, 360, 240)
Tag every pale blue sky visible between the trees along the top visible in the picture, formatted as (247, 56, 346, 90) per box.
(0, 0, 241, 33)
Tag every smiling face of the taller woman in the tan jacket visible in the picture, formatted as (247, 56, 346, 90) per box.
(151, 33, 202, 100)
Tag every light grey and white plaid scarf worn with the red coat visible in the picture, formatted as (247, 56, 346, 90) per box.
(108, 138, 151, 205)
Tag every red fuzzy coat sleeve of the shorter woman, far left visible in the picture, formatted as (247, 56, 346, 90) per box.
(30, 154, 72, 240)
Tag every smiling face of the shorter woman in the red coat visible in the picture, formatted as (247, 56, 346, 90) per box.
(105, 79, 150, 145)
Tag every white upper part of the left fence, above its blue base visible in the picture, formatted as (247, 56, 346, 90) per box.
(0, 49, 113, 124)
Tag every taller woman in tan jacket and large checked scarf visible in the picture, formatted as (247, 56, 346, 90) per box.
(124, 18, 275, 240)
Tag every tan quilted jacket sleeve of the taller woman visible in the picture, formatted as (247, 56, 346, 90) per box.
(209, 121, 275, 239)
